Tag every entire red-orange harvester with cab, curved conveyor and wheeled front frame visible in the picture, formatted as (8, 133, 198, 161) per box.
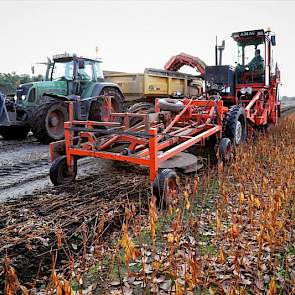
(50, 30, 280, 205)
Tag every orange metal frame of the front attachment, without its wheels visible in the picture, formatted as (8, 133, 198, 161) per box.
(50, 99, 224, 181)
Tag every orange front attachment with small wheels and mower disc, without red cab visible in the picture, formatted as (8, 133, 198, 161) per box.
(50, 97, 232, 205)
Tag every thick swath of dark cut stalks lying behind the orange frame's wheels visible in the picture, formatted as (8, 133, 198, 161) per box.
(0, 169, 148, 290)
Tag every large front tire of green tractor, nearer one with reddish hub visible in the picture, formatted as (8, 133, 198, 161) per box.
(30, 97, 69, 143)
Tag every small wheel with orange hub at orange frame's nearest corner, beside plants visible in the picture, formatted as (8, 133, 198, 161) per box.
(153, 169, 178, 208)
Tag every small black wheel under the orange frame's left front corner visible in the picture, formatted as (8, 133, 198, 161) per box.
(49, 156, 77, 186)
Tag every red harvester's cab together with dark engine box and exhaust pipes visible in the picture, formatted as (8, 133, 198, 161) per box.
(205, 30, 279, 105)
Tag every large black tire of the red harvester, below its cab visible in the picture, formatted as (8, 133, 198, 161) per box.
(224, 105, 247, 146)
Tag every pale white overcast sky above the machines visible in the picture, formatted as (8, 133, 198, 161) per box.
(0, 0, 295, 96)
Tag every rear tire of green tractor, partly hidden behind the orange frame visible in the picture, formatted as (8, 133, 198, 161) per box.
(88, 87, 124, 121)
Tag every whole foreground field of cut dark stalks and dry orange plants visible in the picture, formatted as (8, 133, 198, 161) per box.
(0, 109, 295, 294)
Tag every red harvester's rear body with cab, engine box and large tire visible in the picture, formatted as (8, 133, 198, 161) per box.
(205, 29, 280, 142)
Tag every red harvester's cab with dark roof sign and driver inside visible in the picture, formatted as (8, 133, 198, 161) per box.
(232, 30, 276, 94)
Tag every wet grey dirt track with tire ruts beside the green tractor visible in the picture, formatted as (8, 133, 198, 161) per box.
(0, 136, 110, 202)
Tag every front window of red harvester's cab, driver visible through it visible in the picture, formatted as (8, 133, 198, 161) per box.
(236, 43, 265, 84)
